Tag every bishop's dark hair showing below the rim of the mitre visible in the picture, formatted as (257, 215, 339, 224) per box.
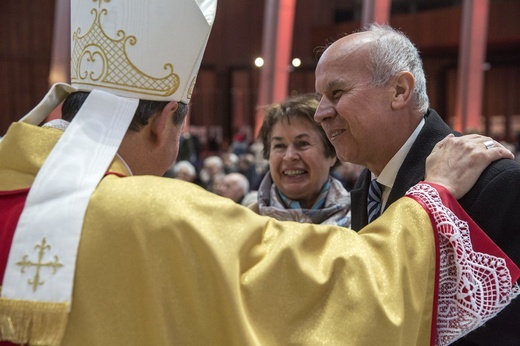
(61, 91, 188, 132)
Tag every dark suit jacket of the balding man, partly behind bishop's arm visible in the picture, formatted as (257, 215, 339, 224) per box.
(350, 109, 520, 346)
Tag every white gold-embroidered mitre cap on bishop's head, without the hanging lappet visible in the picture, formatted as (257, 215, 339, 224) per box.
(71, 0, 216, 103)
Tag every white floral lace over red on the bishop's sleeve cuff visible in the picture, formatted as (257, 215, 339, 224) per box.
(407, 184, 520, 345)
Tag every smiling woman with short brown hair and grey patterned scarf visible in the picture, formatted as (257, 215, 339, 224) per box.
(250, 95, 350, 227)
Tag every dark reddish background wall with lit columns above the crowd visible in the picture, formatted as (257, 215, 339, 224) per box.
(0, 0, 520, 153)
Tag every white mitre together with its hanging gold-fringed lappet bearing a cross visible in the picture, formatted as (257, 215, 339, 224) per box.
(0, 0, 217, 345)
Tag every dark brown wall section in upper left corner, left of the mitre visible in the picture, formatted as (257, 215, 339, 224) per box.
(0, 0, 54, 135)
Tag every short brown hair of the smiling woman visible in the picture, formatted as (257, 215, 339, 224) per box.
(258, 94, 339, 163)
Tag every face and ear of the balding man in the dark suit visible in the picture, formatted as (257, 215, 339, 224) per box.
(314, 35, 398, 172)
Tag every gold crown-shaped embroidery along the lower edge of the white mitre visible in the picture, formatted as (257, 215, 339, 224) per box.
(71, 0, 180, 96)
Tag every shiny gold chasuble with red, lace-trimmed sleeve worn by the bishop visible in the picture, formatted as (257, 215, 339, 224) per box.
(0, 123, 519, 346)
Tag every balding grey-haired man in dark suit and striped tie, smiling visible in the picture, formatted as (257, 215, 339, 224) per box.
(315, 25, 520, 345)
